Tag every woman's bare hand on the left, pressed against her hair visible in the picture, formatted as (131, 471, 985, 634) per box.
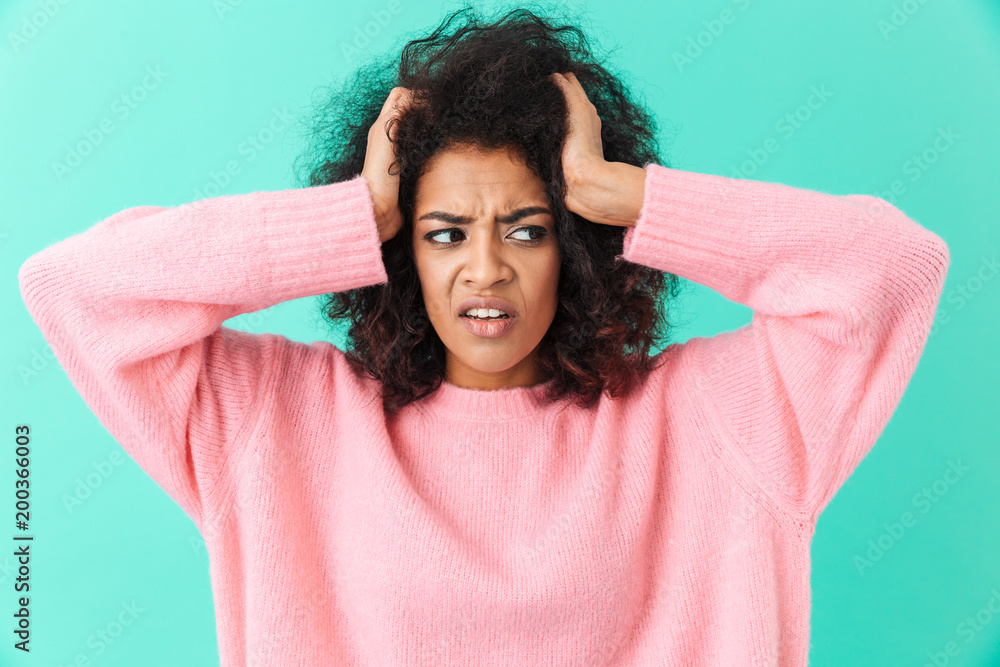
(361, 86, 413, 243)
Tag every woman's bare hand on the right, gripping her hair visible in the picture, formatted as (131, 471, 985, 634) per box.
(550, 72, 646, 227)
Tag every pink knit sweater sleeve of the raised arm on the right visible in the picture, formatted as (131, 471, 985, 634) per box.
(622, 163, 950, 521)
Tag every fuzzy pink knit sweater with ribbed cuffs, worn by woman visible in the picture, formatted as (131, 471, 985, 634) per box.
(19, 163, 950, 667)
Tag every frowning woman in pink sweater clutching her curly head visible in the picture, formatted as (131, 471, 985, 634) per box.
(19, 5, 949, 667)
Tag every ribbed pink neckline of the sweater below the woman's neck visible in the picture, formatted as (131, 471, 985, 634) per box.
(417, 380, 566, 421)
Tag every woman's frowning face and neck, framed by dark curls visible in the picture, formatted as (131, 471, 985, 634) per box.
(413, 145, 559, 389)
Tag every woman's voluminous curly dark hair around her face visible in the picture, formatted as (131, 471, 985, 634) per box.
(296, 6, 681, 411)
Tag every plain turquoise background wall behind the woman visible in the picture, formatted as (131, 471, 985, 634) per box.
(0, 0, 1000, 667)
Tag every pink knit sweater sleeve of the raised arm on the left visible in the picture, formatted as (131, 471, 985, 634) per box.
(18, 176, 388, 530)
